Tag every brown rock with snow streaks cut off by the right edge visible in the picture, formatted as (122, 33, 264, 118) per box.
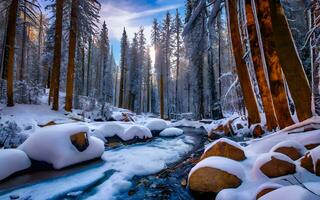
(300, 147, 320, 176)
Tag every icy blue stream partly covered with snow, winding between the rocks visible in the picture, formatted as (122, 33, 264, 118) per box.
(0, 128, 202, 200)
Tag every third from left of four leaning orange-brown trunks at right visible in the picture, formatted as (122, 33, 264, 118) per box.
(252, 0, 293, 129)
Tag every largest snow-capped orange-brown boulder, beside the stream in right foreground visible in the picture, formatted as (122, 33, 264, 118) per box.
(188, 157, 245, 193)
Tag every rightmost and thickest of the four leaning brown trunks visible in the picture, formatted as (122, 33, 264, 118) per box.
(269, 0, 312, 121)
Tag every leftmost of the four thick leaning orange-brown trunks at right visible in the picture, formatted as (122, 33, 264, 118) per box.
(226, 0, 261, 124)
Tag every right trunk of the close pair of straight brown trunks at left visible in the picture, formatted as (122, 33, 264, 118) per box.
(65, 0, 78, 112)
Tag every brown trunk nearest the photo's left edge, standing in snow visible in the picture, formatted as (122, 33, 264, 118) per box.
(3, 0, 19, 107)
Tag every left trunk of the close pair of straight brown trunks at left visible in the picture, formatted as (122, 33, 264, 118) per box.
(50, 0, 63, 111)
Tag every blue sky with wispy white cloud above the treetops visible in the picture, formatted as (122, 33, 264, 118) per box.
(40, 0, 184, 63)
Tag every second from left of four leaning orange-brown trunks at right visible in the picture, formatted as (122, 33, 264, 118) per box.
(245, 0, 278, 131)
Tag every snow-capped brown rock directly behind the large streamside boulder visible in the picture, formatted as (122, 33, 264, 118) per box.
(201, 138, 246, 161)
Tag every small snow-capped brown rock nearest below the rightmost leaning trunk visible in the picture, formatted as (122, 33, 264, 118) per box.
(270, 140, 307, 160)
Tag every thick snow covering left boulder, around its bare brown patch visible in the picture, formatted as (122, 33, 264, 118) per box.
(19, 124, 104, 169)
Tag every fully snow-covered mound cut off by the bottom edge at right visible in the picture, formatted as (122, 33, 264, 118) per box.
(259, 185, 319, 200)
